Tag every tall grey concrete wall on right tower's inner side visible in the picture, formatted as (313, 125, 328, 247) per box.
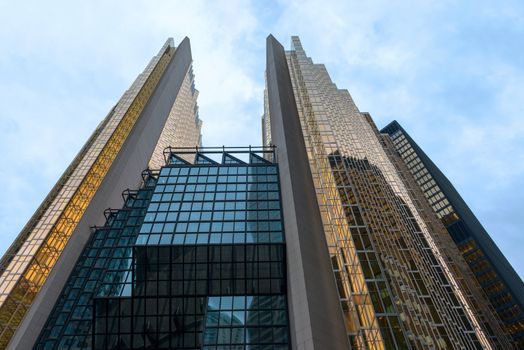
(266, 35, 349, 350)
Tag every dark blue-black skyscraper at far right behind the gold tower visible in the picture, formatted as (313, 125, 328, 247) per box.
(381, 121, 524, 348)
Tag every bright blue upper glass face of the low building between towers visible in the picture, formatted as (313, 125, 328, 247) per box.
(137, 160, 283, 244)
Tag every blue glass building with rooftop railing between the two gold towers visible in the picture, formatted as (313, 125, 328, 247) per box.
(36, 148, 289, 350)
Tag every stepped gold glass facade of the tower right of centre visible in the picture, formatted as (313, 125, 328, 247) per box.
(262, 37, 507, 349)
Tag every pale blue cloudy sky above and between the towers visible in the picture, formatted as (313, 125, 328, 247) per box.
(0, 0, 524, 277)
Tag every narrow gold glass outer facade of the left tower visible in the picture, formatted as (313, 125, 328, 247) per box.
(0, 41, 175, 348)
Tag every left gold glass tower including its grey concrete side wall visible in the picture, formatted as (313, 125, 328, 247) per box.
(0, 38, 201, 348)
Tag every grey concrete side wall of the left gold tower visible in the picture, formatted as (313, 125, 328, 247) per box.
(7, 37, 192, 349)
